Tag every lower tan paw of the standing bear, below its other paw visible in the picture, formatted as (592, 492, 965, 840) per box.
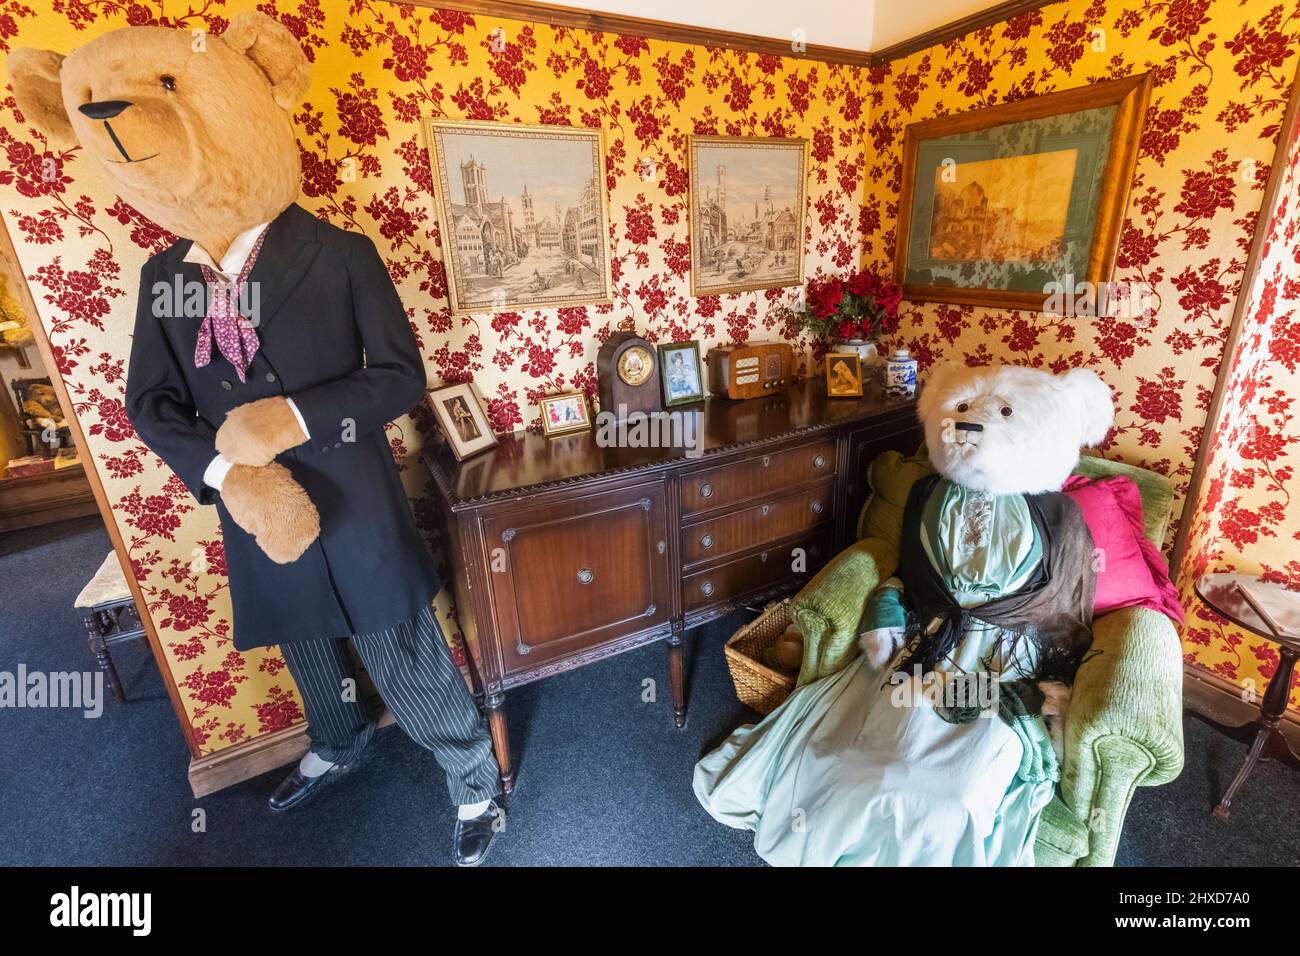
(221, 463, 321, 564)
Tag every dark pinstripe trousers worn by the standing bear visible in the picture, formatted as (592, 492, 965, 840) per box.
(280, 607, 501, 805)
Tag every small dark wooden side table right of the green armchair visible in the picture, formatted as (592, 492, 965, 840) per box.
(1196, 574, 1300, 821)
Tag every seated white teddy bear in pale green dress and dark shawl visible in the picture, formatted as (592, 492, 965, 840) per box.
(694, 367, 1114, 866)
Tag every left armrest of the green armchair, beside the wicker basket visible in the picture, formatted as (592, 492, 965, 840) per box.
(790, 537, 898, 687)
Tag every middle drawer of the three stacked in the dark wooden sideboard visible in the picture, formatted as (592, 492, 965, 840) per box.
(681, 480, 835, 566)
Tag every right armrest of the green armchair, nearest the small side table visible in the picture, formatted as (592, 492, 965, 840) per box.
(1057, 607, 1183, 866)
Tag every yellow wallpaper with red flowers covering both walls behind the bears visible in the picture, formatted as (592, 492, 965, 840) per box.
(0, 0, 1300, 756)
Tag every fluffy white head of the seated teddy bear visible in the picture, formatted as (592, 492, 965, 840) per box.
(917, 365, 1115, 494)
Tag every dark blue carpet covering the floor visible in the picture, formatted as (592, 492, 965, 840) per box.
(0, 518, 1300, 866)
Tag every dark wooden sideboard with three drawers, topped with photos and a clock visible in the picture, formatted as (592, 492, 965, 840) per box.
(424, 380, 920, 792)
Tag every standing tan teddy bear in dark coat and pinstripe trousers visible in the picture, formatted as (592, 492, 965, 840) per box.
(9, 13, 503, 865)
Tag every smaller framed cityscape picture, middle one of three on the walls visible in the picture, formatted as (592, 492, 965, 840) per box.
(688, 135, 809, 295)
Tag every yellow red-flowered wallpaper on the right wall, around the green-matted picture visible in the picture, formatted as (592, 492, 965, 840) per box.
(863, 0, 1300, 712)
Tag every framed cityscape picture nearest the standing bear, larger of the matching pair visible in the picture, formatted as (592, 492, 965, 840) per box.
(424, 118, 614, 313)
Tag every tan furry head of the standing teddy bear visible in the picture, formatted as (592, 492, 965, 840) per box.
(8, 12, 309, 256)
